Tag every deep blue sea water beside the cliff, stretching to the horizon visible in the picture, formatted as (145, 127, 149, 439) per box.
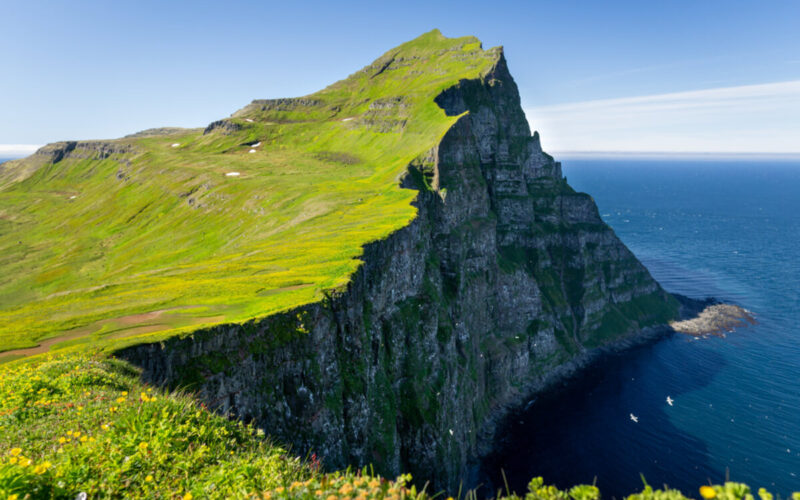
(496, 160, 800, 498)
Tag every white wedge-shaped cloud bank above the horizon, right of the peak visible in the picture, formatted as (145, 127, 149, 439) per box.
(526, 80, 800, 153)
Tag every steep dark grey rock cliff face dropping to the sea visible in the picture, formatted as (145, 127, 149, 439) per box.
(118, 47, 677, 490)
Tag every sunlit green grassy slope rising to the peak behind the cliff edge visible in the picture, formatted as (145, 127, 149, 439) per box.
(0, 30, 501, 361)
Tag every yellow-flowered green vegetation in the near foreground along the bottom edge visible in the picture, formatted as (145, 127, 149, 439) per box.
(0, 354, 800, 500)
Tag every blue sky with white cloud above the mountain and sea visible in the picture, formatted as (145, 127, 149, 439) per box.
(0, 0, 800, 156)
